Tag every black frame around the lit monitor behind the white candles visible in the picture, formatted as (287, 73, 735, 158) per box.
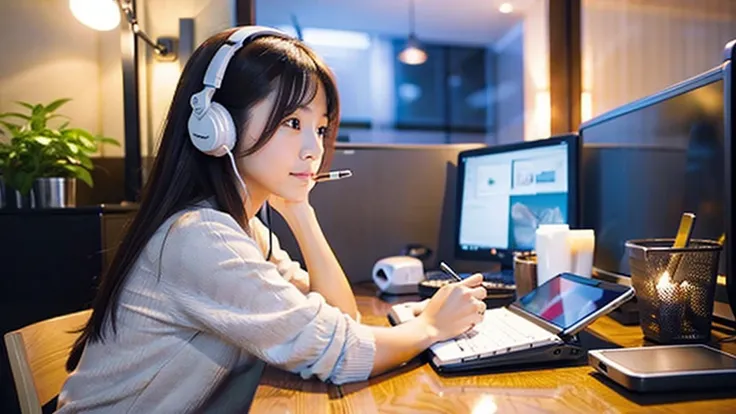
(453, 133, 581, 268)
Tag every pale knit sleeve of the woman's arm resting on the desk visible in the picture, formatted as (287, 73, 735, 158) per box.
(161, 209, 375, 384)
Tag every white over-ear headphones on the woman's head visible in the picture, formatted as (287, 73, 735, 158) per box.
(187, 26, 291, 157)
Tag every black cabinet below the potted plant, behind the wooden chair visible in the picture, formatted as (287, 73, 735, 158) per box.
(0, 205, 135, 413)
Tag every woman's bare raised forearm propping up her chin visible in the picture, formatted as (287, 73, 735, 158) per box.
(274, 203, 358, 319)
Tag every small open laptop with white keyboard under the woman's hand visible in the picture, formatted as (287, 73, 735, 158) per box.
(388, 273, 634, 372)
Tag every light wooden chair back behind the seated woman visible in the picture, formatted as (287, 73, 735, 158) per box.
(4, 309, 92, 414)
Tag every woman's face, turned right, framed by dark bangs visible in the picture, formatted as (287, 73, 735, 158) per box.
(237, 82, 328, 205)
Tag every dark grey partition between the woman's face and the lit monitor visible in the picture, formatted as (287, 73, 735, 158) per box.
(272, 144, 480, 283)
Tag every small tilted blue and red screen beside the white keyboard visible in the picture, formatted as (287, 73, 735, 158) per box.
(516, 273, 626, 330)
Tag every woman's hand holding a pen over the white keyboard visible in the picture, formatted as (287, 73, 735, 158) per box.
(415, 274, 486, 342)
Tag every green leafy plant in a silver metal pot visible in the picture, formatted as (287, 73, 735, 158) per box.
(0, 98, 120, 208)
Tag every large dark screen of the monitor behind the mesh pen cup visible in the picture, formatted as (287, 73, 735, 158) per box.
(580, 69, 727, 277)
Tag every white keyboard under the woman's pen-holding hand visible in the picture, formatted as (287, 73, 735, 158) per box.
(432, 308, 561, 363)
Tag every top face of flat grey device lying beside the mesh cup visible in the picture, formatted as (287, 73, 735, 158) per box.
(603, 345, 736, 374)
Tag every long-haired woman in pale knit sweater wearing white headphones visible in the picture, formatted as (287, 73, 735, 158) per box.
(59, 27, 485, 413)
